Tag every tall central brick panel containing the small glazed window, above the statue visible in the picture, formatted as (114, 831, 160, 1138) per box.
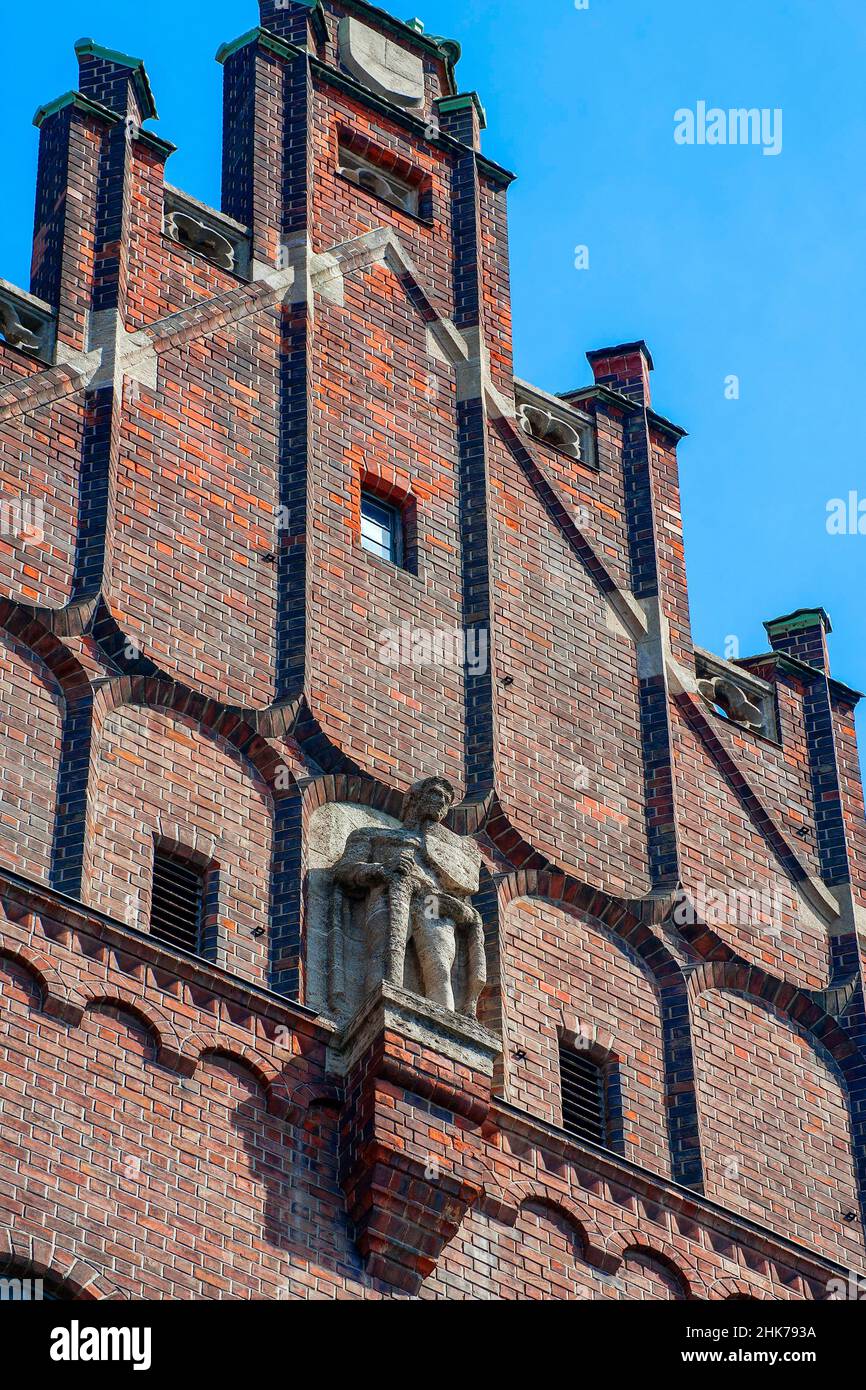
(309, 255, 464, 785)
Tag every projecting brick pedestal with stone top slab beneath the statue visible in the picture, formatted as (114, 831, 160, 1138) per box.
(329, 984, 502, 1294)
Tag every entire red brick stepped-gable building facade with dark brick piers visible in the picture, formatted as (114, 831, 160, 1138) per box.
(0, 0, 866, 1300)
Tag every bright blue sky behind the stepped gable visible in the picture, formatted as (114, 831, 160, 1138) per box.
(0, 0, 866, 761)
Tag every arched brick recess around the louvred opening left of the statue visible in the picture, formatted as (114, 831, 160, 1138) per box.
(82, 676, 276, 983)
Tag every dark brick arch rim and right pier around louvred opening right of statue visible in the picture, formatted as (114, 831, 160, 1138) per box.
(499, 869, 702, 1187)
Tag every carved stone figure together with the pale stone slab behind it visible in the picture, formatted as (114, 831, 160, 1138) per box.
(307, 777, 487, 1020)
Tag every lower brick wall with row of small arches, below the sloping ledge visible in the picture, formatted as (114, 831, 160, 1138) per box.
(0, 899, 856, 1298)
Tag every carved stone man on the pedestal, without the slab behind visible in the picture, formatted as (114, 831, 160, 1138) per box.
(328, 777, 487, 1017)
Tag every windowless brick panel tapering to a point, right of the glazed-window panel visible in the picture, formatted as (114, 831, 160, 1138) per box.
(491, 428, 649, 897)
